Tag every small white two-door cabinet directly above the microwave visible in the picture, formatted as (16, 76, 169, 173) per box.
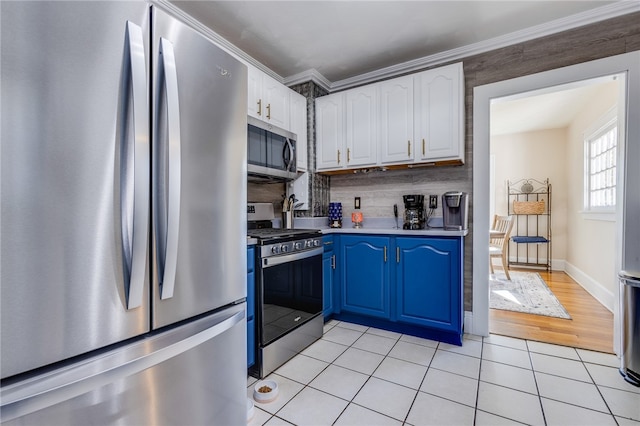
(247, 66, 291, 130)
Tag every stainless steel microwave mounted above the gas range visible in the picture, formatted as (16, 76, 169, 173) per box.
(247, 117, 297, 182)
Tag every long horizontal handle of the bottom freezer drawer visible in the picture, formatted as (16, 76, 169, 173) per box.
(0, 306, 245, 423)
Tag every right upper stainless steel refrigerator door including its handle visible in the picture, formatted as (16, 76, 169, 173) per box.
(152, 6, 247, 328)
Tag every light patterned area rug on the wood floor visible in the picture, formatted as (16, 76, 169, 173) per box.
(489, 271, 571, 319)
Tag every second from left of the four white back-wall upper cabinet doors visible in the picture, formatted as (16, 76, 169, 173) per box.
(345, 85, 378, 167)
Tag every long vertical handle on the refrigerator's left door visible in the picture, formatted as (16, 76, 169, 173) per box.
(118, 21, 149, 309)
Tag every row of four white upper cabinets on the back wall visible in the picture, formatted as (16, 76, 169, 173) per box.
(316, 63, 464, 171)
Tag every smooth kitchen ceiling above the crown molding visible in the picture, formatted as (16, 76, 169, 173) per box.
(169, 0, 624, 83)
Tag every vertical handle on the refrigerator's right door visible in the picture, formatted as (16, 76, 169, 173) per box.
(154, 38, 181, 299)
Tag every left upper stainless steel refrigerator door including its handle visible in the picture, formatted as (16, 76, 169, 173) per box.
(0, 1, 150, 378)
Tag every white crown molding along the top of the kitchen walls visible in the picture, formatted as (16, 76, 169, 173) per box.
(154, 0, 640, 92)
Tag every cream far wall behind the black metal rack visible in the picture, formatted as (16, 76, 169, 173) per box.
(490, 128, 576, 267)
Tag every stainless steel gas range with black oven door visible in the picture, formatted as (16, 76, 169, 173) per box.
(247, 203, 324, 378)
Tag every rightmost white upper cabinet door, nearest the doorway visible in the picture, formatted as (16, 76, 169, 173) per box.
(415, 63, 464, 161)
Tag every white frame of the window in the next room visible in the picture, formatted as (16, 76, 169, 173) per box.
(582, 106, 620, 221)
